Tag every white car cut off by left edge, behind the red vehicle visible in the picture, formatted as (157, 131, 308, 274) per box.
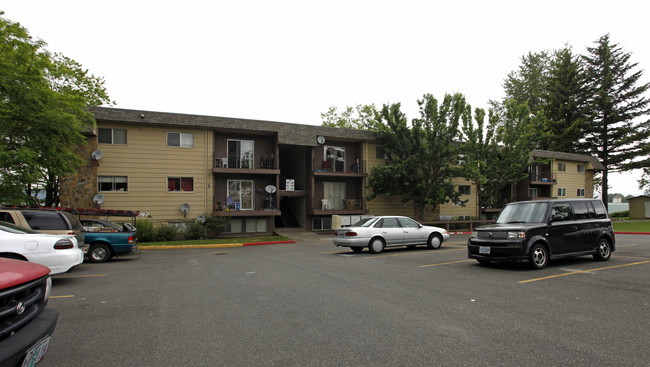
(0, 222, 84, 274)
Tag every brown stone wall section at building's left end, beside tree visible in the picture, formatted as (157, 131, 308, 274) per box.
(60, 137, 99, 208)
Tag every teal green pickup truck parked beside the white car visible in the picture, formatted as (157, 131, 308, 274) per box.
(81, 219, 138, 263)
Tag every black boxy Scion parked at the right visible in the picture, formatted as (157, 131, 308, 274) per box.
(467, 199, 615, 269)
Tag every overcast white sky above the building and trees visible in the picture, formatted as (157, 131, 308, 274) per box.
(0, 0, 650, 195)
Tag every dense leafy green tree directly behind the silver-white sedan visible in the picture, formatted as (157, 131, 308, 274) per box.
(368, 94, 466, 220)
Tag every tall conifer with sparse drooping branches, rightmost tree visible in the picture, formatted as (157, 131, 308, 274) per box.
(583, 34, 650, 205)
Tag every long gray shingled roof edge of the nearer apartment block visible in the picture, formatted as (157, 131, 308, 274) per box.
(88, 107, 377, 146)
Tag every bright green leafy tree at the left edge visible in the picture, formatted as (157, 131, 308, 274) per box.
(0, 13, 111, 205)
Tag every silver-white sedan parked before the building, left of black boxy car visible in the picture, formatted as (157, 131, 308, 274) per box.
(334, 216, 449, 254)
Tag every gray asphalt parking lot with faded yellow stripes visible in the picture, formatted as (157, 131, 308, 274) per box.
(42, 235, 650, 366)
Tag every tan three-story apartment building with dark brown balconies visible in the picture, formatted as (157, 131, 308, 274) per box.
(61, 107, 603, 234)
